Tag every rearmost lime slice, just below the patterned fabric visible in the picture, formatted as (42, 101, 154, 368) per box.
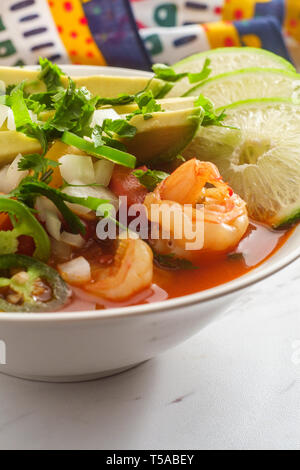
(168, 47, 296, 97)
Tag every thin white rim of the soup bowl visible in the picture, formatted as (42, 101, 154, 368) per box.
(0, 65, 300, 323)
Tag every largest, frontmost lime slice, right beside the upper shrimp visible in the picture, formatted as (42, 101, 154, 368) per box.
(183, 99, 300, 228)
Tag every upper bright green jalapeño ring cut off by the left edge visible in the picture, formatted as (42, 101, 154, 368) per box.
(0, 196, 50, 261)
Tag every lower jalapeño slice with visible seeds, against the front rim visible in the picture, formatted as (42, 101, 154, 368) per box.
(0, 255, 70, 313)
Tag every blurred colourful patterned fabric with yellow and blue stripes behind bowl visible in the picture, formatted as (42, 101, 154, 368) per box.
(0, 0, 300, 70)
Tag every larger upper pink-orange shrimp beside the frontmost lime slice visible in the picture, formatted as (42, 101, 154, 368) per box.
(144, 158, 249, 260)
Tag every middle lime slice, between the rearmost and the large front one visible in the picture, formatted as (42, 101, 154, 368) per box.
(186, 68, 300, 108)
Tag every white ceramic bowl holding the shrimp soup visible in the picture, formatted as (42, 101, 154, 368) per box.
(0, 66, 300, 382)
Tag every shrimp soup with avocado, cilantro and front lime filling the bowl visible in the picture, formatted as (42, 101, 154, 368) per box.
(0, 59, 300, 313)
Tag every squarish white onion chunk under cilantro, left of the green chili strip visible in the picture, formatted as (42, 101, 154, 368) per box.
(58, 155, 95, 184)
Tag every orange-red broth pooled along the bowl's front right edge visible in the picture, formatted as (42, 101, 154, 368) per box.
(63, 222, 292, 311)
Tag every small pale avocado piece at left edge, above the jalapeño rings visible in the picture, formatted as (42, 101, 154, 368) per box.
(0, 131, 42, 167)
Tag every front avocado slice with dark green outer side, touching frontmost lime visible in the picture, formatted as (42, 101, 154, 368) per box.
(122, 107, 204, 164)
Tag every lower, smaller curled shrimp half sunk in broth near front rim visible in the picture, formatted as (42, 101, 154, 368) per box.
(85, 237, 153, 301)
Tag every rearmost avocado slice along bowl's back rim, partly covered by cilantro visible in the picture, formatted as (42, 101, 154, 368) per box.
(0, 67, 165, 98)
